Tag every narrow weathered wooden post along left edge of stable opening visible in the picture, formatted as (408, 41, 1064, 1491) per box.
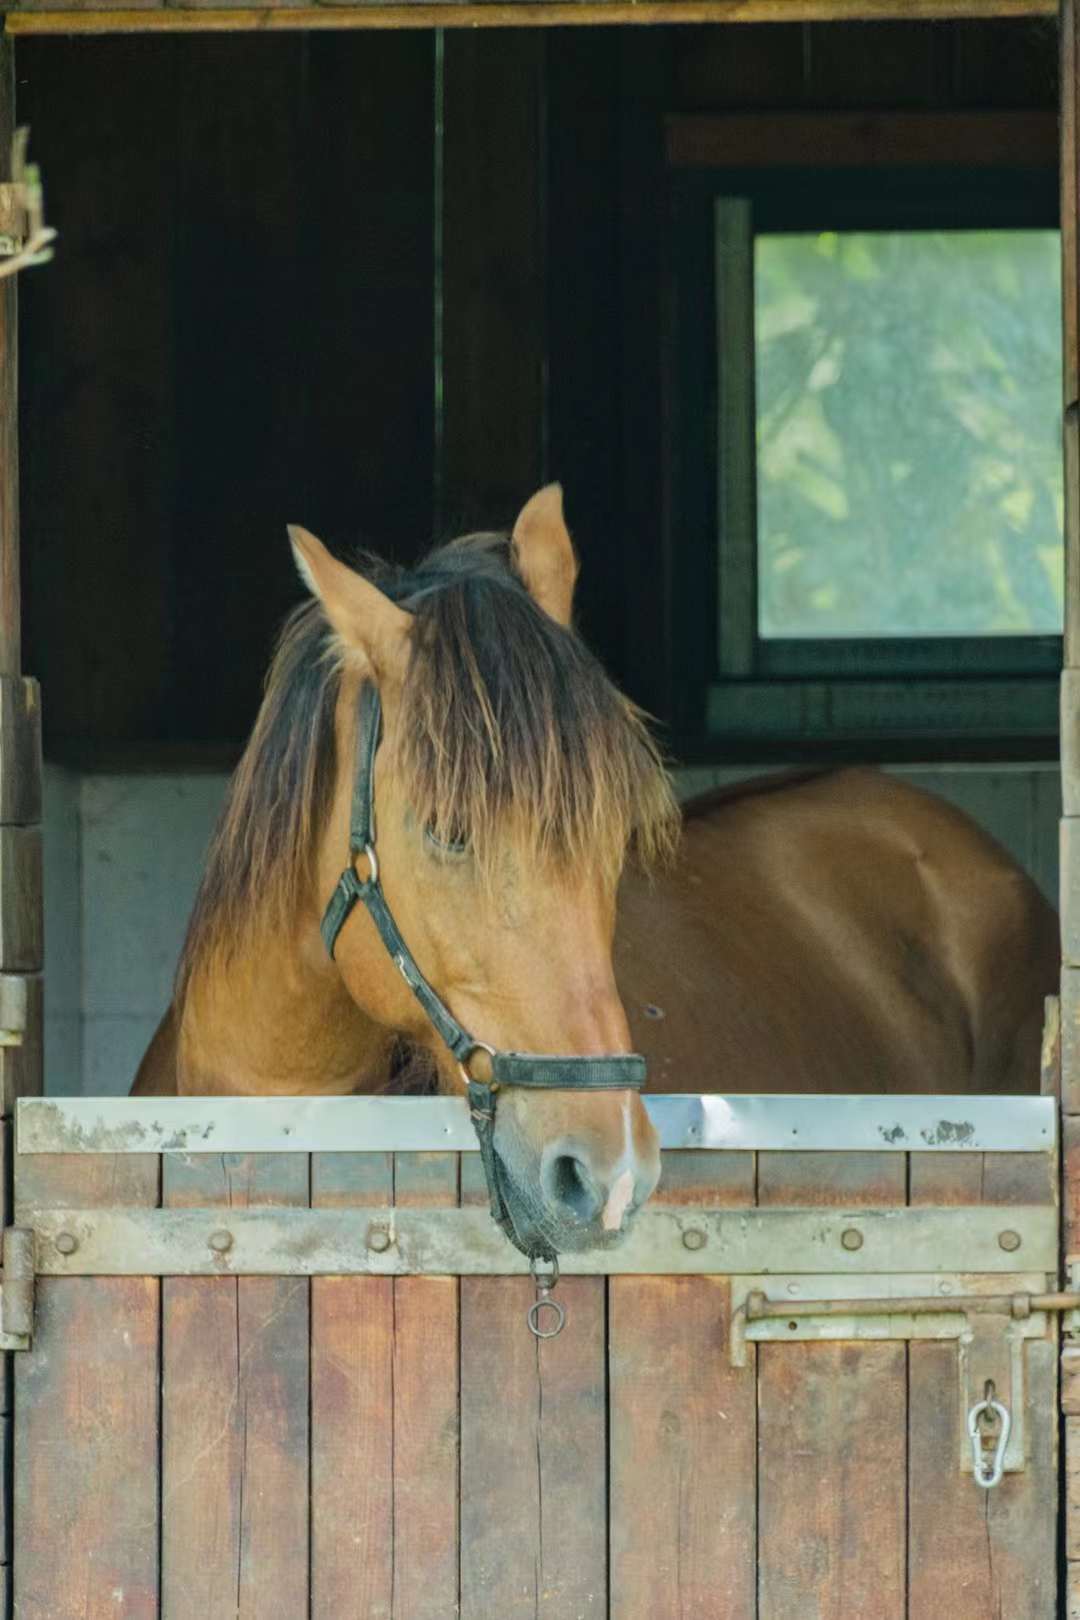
(0, 36, 42, 1614)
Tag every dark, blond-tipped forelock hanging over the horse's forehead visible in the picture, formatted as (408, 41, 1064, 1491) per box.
(395, 535, 678, 900)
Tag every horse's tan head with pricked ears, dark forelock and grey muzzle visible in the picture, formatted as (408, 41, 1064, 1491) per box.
(290, 486, 677, 1252)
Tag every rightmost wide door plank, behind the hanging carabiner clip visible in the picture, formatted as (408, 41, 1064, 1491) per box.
(908, 1153, 1057, 1620)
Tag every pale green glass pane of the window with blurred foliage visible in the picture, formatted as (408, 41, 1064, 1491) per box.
(755, 230, 1064, 637)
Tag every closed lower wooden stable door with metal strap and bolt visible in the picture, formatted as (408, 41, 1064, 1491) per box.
(4, 1098, 1057, 1620)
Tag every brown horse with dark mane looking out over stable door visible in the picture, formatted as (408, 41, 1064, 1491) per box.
(133, 486, 1057, 1252)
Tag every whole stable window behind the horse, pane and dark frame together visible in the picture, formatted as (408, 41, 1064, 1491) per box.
(669, 115, 1064, 753)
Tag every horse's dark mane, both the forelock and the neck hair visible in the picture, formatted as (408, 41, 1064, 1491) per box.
(176, 535, 680, 1001)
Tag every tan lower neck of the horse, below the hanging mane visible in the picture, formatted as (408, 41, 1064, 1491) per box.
(176, 922, 393, 1097)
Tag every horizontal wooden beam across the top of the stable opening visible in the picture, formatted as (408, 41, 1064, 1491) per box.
(5, 0, 1057, 36)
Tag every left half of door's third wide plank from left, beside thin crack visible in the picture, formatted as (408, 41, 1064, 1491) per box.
(311, 1153, 393, 1620)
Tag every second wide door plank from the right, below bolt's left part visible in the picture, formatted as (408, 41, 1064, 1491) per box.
(758, 1153, 907, 1620)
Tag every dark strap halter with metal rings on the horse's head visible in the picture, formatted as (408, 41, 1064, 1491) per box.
(321, 682, 644, 1259)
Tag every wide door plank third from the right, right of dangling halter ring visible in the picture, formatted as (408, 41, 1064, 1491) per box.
(609, 1152, 756, 1620)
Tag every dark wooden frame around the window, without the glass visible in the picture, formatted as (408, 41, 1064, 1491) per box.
(665, 113, 1061, 758)
